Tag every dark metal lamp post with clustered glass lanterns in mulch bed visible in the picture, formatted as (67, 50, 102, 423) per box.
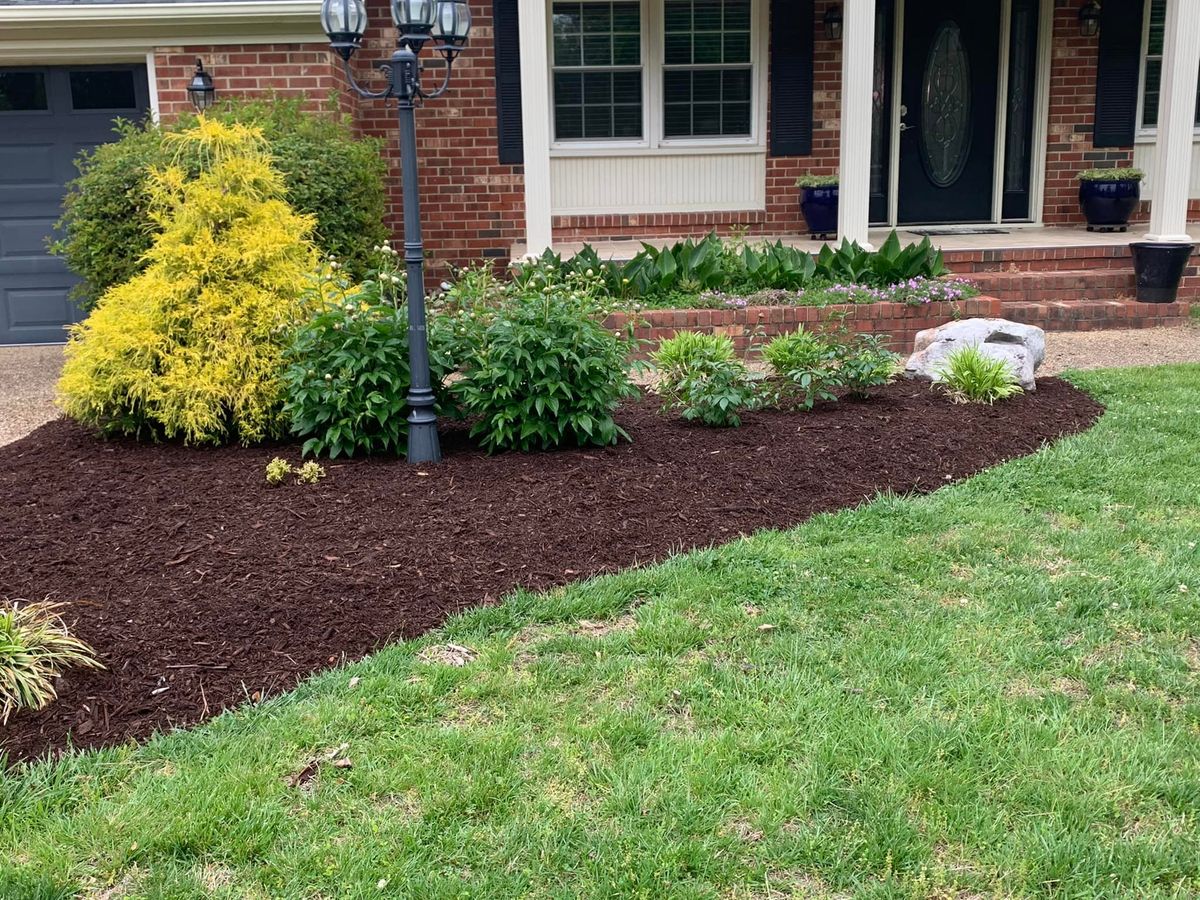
(320, 0, 470, 463)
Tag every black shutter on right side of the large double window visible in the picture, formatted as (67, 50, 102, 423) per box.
(770, 0, 815, 156)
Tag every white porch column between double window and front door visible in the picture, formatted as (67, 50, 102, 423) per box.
(838, 0, 878, 247)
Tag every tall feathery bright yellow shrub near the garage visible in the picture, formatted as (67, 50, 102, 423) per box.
(59, 118, 317, 444)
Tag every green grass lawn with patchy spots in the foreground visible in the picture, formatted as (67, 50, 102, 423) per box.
(0, 366, 1200, 900)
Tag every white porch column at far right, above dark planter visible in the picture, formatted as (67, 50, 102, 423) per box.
(1146, 0, 1200, 242)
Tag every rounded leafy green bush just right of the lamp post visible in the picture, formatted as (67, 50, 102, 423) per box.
(451, 276, 637, 452)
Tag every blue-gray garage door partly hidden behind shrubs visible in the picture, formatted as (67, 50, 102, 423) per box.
(0, 66, 149, 344)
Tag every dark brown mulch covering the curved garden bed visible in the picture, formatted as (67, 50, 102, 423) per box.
(0, 379, 1100, 761)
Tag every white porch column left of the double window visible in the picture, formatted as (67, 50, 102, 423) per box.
(517, 0, 552, 256)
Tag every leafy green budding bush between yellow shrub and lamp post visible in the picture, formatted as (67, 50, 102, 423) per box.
(283, 251, 450, 458)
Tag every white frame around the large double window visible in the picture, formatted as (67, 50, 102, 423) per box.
(546, 0, 768, 156)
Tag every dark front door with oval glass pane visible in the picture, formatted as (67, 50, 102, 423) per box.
(899, 0, 1001, 224)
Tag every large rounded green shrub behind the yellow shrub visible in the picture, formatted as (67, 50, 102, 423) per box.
(52, 98, 386, 311)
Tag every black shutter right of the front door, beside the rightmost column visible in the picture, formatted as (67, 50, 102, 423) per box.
(1092, 0, 1145, 146)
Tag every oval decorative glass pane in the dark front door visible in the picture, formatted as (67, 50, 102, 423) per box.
(920, 22, 971, 187)
